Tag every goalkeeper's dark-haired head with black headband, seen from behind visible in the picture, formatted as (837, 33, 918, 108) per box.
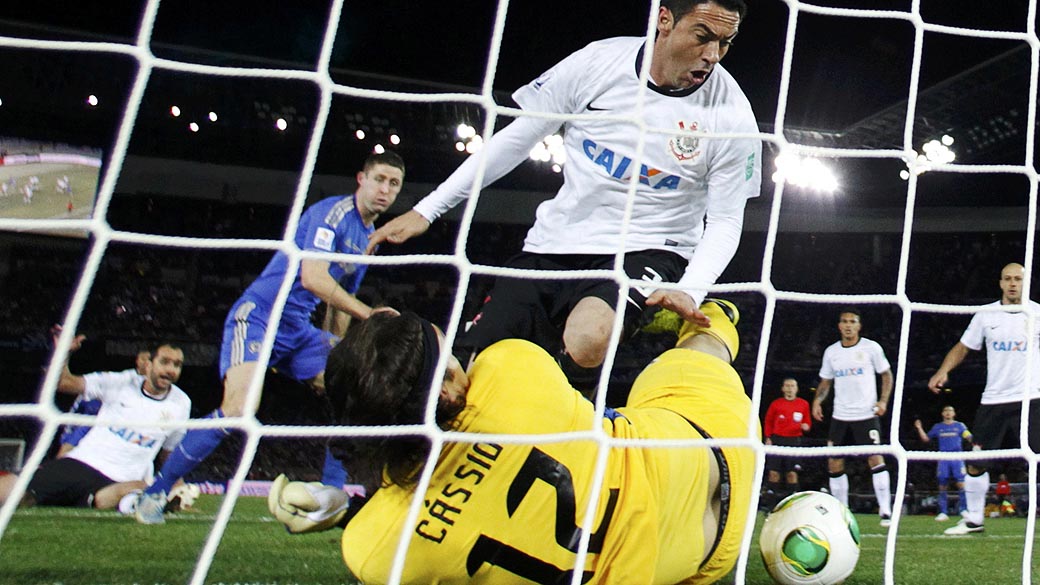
(326, 312, 469, 487)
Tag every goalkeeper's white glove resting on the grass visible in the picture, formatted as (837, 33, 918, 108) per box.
(267, 474, 349, 534)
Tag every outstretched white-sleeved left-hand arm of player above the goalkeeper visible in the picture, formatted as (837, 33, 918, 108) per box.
(365, 116, 560, 254)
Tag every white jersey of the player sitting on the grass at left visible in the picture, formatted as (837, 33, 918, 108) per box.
(69, 370, 191, 482)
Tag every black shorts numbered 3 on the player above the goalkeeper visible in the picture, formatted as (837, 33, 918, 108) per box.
(454, 250, 687, 363)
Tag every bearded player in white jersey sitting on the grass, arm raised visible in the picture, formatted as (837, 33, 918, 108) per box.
(0, 337, 191, 509)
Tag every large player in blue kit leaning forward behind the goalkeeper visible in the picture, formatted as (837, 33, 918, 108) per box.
(135, 152, 405, 524)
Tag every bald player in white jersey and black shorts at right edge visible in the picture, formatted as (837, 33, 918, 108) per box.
(928, 262, 1040, 534)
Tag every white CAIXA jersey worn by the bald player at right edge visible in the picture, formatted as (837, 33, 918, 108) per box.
(961, 301, 1040, 404)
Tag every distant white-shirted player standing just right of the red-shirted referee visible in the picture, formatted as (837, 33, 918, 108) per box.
(812, 309, 892, 527)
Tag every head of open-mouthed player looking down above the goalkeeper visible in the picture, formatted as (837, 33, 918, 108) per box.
(650, 0, 748, 90)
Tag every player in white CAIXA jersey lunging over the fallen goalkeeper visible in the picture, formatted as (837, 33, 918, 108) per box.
(369, 0, 761, 389)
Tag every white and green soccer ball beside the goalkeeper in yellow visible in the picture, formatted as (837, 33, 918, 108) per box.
(758, 491, 859, 585)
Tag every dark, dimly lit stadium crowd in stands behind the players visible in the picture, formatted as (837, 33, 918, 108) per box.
(0, 195, 1024, 501)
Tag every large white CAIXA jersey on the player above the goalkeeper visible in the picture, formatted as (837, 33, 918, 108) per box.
(415, 37, 761, 297)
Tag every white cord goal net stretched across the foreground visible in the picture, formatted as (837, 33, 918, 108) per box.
(0, 0, 1040, 583)
